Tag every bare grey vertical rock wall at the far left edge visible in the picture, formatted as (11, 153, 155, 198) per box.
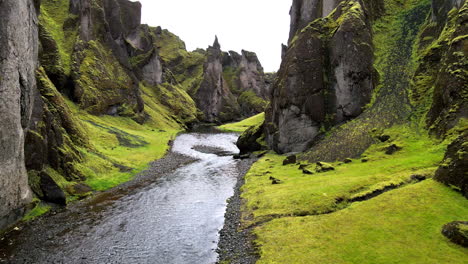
(0, 0, 38, 229)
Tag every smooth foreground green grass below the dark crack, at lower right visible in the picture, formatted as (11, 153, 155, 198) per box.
(255, 180, 468, 264)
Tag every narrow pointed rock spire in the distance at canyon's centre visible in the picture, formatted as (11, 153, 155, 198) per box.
(195, 38, 239, 122)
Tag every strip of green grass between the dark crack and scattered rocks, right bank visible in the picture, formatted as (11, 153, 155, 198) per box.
(242, 127, 446, 223)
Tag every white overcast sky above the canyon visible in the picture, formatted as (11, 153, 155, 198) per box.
(133, 0, 292, 72)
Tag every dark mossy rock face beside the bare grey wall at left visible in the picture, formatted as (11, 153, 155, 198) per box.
(25, 67, 87, 204)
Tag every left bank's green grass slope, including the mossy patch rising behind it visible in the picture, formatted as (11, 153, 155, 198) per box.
(63, 80, 190, 191)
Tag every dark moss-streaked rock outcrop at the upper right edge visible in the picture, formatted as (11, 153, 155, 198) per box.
(424, 1, 468, 136)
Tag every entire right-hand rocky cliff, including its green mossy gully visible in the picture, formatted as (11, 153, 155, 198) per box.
(258, 0, 468, 190)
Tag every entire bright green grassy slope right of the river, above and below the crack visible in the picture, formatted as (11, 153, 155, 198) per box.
(242, 127, 468, 263)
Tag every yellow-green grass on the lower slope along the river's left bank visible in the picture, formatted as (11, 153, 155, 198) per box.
(65, 102, 182, 191)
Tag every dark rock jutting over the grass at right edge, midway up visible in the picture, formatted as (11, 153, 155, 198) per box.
(434, 131, 468, 198)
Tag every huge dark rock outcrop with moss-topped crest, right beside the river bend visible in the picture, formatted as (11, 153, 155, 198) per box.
(266, 1, 377, 153)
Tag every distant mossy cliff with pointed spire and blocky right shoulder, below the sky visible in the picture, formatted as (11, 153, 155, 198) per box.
(195, 38, 270, 122)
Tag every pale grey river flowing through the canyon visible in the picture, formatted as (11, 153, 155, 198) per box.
(0, 133, 239, 264)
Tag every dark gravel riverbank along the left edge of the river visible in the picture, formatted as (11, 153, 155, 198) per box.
(0, 151, 196, 264)
